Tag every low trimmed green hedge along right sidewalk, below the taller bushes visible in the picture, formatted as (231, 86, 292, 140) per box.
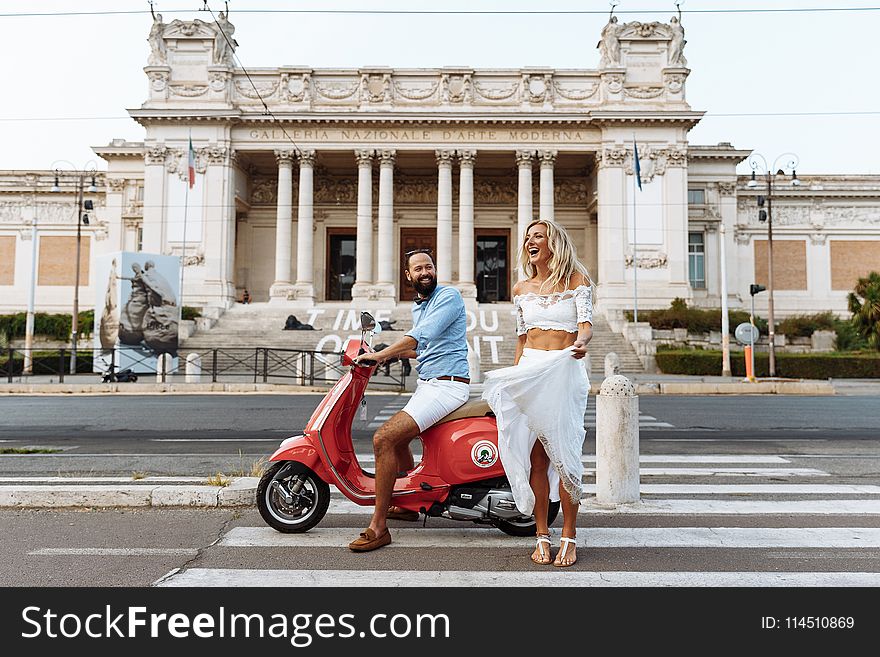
(656, 349, 880, 379)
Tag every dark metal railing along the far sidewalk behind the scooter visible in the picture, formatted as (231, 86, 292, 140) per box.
(0, 347, 410, 391)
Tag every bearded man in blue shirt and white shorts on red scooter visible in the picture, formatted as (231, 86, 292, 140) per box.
(348, 249, 470, 552)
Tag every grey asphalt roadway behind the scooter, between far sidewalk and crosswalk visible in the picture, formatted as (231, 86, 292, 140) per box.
(0, 394, 880, 475)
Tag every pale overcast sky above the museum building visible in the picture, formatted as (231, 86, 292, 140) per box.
(0, 0, 880, 174)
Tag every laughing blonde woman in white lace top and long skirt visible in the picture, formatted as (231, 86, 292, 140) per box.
(483, 219, 593, 567)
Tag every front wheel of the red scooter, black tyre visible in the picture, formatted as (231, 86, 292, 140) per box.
(257, 461, 330, 534)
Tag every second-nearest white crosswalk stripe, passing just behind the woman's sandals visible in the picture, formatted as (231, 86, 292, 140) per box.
(219, 527, 880, 549)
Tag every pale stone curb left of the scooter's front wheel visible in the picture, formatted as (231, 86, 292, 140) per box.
(0, 477, 259, 509)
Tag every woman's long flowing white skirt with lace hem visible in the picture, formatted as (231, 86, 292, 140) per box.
(483, 347, 590, 514)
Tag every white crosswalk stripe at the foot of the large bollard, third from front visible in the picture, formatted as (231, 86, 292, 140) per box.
(304, 498, 880, 516)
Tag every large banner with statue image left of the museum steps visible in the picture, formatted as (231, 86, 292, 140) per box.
(94, 251, 180, 374)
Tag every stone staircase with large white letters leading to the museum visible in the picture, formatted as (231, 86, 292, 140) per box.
(180, 302, 644, 377)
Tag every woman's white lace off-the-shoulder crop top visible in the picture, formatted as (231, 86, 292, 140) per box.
(513, 285, 593, 335)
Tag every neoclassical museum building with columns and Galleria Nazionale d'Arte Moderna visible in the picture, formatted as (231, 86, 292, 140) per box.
(0, 16, 880, 319)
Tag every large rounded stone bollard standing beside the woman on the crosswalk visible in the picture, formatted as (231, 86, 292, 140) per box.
(596, 374, 639, 504)
